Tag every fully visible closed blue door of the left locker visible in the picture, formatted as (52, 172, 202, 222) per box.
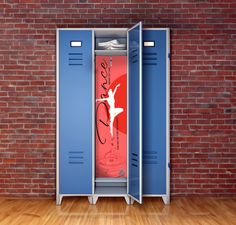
(57, 30, 93, 194)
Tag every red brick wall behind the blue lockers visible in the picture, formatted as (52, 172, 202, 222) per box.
(0, 0, 236, 196)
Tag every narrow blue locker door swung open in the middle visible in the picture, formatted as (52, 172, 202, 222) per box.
(127, 22, 142, 204)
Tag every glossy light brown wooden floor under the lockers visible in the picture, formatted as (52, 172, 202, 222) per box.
(0, 197, 236, 225)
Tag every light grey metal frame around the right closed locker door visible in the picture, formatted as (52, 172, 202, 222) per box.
(142, 28, 170, 204)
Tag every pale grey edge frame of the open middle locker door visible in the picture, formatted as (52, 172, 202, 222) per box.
(127, 21, 143, 204)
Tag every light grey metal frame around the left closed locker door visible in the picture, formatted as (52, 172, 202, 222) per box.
(56, 28, 95, 205)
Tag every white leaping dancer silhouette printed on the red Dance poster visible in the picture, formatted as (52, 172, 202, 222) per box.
(96, 84, 124, 137)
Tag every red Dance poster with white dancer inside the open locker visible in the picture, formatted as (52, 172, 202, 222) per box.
(96, 56, 127, 178)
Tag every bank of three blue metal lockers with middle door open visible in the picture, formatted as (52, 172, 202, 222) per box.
(56, 22, 170, 204)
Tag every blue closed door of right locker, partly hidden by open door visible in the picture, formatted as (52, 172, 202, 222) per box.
(143, 30, 167, 195)
